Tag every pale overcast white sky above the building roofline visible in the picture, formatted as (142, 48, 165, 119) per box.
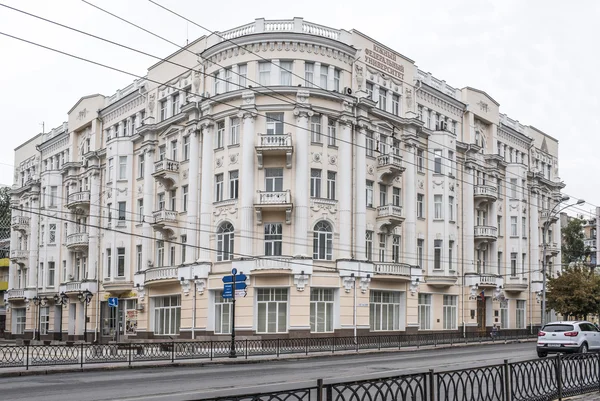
(0, 0, 600, 219)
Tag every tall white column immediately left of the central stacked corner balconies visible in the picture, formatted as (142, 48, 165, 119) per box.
(240, 112, 256, 256)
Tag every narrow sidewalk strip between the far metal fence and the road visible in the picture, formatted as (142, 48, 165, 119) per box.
(0, 338, 537, 377)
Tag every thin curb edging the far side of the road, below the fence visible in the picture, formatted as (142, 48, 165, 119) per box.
(0, 338, 537, 378)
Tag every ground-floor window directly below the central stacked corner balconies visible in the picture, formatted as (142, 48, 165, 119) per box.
(256, 288, 288, 333)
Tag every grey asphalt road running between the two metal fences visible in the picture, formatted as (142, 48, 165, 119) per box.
(0, 342, 537, 401)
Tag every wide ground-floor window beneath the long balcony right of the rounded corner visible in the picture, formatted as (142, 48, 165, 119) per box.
(369, 290, 400, 331)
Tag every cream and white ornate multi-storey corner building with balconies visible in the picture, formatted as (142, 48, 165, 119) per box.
(2, 18, 564, 341)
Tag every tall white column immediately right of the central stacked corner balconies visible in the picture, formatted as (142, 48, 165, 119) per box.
(293, 108, 316, 257)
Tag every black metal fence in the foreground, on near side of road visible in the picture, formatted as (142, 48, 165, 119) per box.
(195, 354, 600, 401)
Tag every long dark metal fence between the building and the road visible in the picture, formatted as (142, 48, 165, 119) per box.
(0, 329, 537, 369)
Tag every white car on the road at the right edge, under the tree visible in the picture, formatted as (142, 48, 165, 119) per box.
(537, 321, 600, 358)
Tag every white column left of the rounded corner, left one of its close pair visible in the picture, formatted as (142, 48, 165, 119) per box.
(184, 129, 200, 264)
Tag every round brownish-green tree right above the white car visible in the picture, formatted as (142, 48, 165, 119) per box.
(546, 263, 600, 319)
